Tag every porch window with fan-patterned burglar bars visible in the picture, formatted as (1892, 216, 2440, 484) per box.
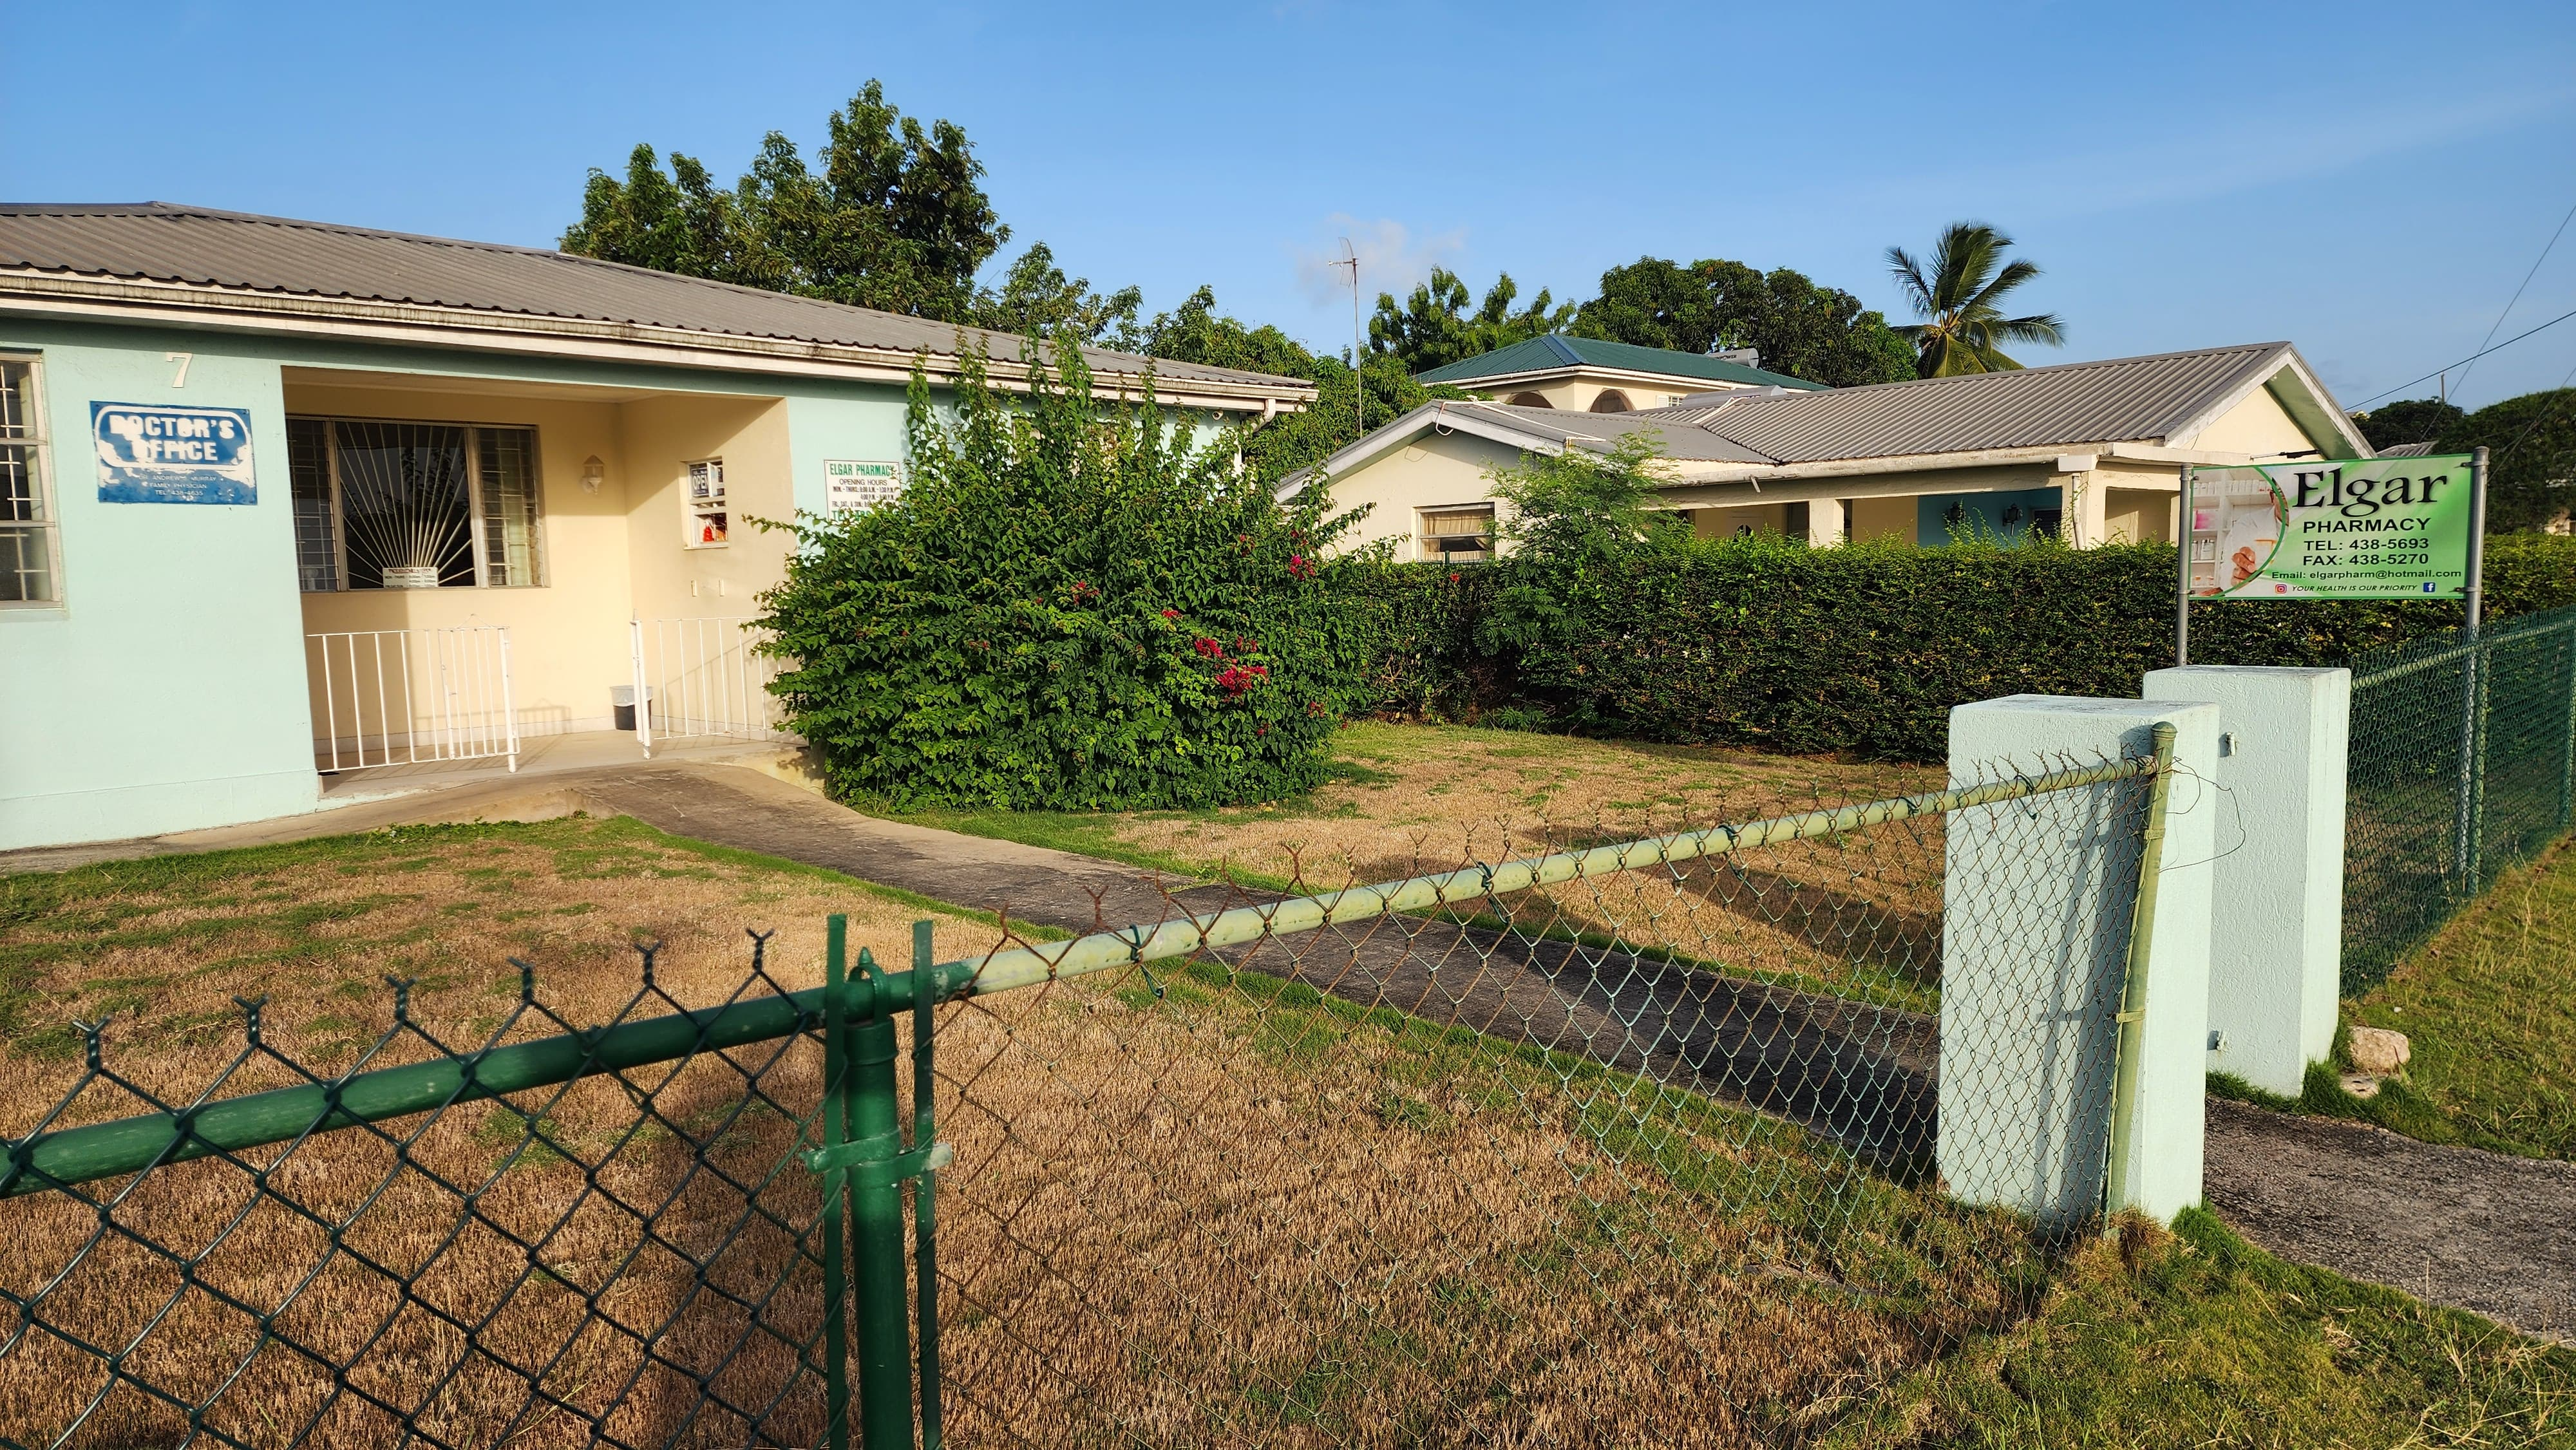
(286, 417, 544, 592)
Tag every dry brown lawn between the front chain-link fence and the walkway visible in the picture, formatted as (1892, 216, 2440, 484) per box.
(0, 822, 2035, 1447)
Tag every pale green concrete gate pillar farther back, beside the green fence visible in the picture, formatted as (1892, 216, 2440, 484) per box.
(2146, 664, 2352, 1097)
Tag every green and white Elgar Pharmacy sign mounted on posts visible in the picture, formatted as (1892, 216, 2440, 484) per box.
(2182, 453, 2476, 600)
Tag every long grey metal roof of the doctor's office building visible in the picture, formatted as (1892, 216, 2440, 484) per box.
(0, 201, 1314, 397)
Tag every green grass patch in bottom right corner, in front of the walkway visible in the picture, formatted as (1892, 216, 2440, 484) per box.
(1824, 1210, 2576, 1450)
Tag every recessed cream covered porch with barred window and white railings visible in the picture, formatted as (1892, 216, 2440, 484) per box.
(283, 368, 796, 801)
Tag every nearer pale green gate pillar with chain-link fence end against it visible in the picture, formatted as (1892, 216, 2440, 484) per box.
(1937, 695, 2218, 1226)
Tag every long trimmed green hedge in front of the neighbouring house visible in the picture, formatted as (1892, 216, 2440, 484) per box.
(1332, 536, 2576, 760)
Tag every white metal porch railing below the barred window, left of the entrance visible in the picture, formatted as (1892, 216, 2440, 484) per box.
(304, 623, 518, 775)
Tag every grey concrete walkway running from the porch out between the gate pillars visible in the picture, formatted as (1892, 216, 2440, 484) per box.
(15, 760, 2576, 1339)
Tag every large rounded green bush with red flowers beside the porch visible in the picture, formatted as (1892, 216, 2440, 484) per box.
(762, 350, 1355, 809)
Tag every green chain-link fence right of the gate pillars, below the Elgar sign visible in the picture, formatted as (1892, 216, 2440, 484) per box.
(2344, 608, 2576, 997)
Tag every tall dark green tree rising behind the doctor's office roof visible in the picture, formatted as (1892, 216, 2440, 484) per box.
(562, 80, 1010, 322)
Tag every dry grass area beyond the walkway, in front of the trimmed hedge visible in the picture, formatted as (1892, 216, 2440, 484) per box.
(920, 724, 1945, 1010)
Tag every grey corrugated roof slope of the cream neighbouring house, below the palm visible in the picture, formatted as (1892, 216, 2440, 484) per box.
(1636, 343, 2295, 464)
